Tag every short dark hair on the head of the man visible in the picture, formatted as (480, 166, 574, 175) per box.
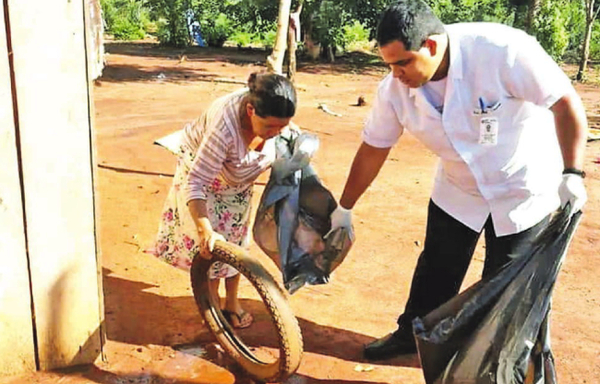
(377, 0, 445, 51)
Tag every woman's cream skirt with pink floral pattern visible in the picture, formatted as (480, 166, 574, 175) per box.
(152, 146, 252, 279)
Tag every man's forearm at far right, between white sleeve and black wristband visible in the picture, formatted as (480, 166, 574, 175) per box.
(551, 94, 588, 169)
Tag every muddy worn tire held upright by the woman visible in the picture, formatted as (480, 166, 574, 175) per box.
(191, 241, 303, 382)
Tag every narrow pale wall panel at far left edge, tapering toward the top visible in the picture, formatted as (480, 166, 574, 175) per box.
(0, 2, 35, 374)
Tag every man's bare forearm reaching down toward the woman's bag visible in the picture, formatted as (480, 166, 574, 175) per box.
(340, 143, 391, 209)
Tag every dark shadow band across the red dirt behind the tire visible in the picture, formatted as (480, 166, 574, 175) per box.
(104, 269, 419, 383)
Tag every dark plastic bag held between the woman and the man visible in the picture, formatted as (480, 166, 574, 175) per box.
(252, 130, 352, 293)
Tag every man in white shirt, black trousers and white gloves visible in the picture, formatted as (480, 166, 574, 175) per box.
(331, 0, 587, 360)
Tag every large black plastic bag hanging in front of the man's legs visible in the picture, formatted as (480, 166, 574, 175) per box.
(413, 205, 581, 384)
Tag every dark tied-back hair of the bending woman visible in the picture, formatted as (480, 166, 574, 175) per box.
(248, 72, 296, 118)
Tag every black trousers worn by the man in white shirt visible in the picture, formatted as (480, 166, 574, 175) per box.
(397, 200, 550, 334)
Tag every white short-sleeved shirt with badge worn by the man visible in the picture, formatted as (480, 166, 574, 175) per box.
(363, 23, 575, 236)
